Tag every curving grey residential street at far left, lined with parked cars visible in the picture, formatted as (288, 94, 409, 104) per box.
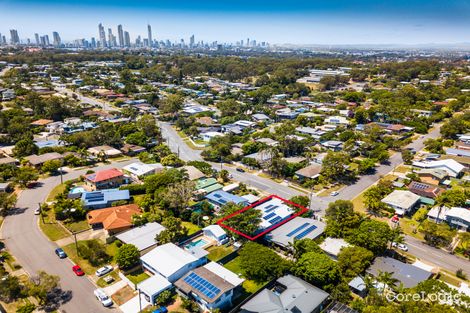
(1, 160, 135, 313)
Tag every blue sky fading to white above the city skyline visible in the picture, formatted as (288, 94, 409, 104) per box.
(0, 0, 470, 45)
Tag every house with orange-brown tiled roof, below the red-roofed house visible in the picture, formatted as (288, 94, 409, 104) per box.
(87, 204, 142, 235)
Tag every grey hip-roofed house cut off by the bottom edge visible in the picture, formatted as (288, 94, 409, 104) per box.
(240, 275, 329, 313)
